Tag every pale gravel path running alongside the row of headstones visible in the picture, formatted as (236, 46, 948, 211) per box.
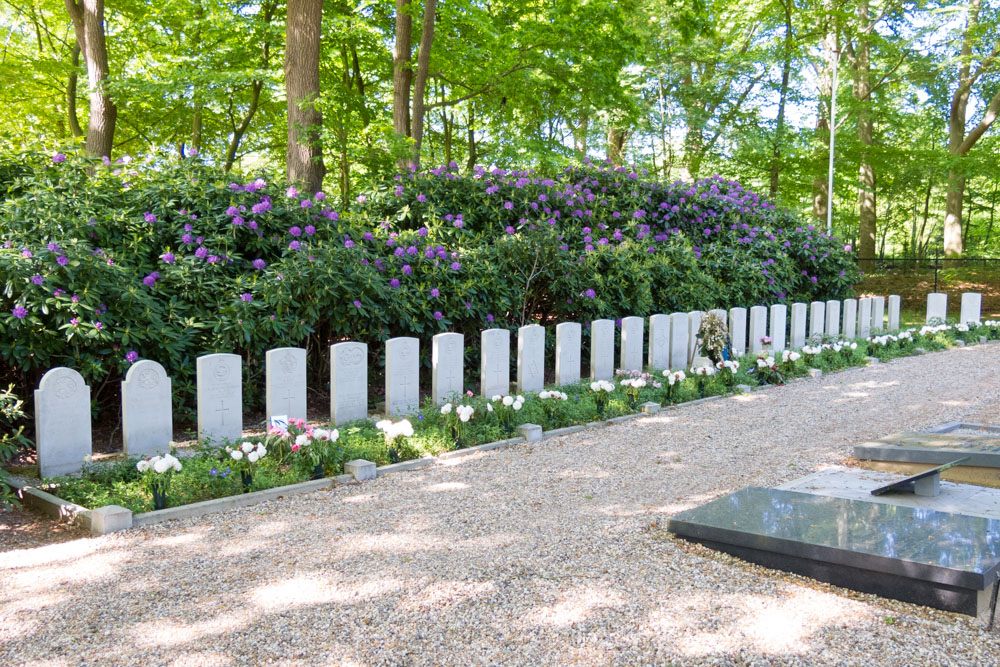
(0, 345, 1000, 665)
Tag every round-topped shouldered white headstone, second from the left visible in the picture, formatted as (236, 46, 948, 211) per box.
(122, 359, 174, 456)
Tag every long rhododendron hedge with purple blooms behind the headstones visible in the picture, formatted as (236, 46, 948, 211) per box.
(0, 156, 858, 420)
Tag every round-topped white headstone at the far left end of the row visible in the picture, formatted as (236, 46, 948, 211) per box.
(35, 367, 91, 477)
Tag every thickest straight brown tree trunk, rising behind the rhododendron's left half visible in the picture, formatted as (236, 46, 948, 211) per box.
(285, 0, 326, 192)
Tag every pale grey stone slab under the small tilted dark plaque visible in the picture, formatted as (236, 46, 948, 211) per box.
(777, 466, 1000, 520)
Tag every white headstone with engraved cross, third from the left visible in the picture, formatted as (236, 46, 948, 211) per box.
(197, 354, 243, 446)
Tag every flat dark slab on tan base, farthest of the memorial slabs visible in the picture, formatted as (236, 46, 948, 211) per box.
(854, 433, 1000, 468)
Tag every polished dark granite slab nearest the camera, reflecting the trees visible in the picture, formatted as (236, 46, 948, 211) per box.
(667, 487, 1000, 617)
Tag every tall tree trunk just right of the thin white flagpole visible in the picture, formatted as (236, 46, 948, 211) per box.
(854, 0, 877, 271)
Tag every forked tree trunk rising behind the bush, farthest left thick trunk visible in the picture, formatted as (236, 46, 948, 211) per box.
(64, 0, 118, 157)
